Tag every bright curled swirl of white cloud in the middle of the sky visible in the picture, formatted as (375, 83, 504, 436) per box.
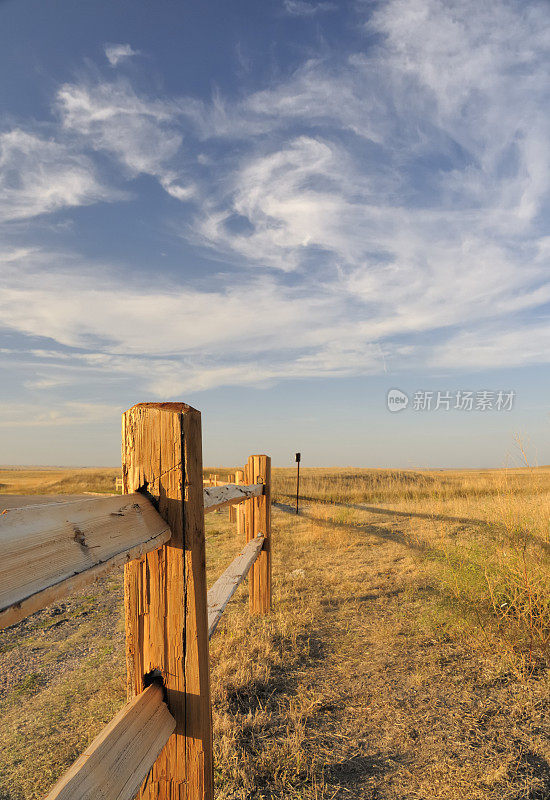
(196, 137, 365, 271)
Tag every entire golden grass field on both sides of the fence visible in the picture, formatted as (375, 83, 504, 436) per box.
(0, 468, 550, 800)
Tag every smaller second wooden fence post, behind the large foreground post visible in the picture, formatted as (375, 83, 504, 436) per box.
(245, 455, 271, 614)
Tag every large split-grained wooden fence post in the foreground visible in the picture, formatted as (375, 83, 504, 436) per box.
(122, 403, 213, 800)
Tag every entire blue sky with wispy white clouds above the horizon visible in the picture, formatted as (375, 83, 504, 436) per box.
(0, 0, 550, 467)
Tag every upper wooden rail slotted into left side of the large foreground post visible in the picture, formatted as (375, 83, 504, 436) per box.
(0, 494, 172, 627)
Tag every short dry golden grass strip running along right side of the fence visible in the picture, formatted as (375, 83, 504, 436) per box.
(209, 504, 550, 800)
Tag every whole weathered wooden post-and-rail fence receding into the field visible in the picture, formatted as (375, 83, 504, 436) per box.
(0, 403, 271, 800)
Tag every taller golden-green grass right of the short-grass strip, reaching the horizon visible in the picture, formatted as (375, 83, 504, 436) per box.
(275, 467, 550, 669)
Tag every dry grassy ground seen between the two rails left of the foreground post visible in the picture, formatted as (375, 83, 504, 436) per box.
(0, 571, 125, 800)
